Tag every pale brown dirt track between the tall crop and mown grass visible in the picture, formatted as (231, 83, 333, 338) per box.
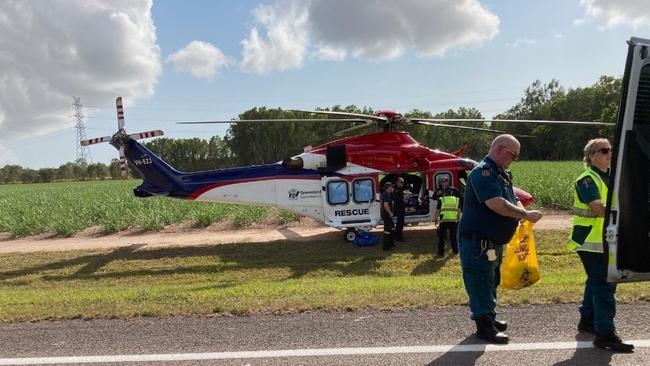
(0, 211, 571, 253)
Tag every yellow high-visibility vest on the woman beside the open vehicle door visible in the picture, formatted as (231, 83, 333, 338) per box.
(568, 168, 607, 253)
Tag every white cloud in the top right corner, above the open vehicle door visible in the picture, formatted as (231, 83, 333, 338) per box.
(574, 0, 650, 28)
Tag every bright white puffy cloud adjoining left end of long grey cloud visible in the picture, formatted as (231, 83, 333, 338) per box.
(240, 1, 308, 74)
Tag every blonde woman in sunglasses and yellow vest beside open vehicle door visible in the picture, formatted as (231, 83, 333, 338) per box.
(568, 138, 634, 352)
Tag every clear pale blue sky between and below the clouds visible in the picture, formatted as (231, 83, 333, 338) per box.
(0, 0, 650, 168)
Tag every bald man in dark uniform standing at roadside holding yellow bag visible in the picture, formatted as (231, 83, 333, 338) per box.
(458, 135, 542, 343)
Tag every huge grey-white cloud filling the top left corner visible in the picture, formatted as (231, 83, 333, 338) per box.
(0, 0, 162, 141)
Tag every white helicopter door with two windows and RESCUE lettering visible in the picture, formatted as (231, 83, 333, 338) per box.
(323, 177, 379, 228)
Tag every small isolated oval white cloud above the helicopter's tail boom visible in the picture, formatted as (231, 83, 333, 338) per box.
(167, 41, 230, 79)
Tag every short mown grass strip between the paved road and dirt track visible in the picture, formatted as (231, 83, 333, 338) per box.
(0, 230, 650, 321)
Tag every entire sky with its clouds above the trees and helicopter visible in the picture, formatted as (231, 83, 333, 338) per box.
(0, 0, 650, 169)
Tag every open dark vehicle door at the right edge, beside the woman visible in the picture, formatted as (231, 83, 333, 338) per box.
(604, 38, 650, 282)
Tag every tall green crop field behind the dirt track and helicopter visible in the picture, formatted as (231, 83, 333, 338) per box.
(0, 162, 581, 236)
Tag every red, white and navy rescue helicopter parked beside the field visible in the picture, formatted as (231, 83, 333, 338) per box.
(81, 98, 603, 241)
